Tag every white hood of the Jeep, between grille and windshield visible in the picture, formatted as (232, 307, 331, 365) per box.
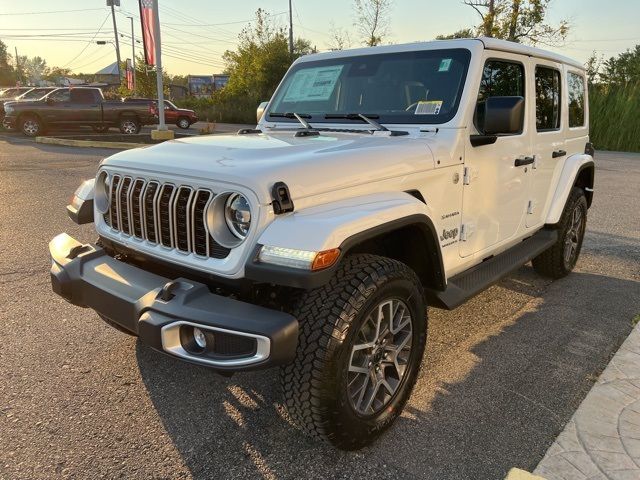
(104, 131, 434, 204)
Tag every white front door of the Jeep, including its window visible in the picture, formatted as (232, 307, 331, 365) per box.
(460, 53, 532, 257)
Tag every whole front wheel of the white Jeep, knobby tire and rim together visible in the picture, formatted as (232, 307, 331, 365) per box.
(281, 255, 427, 450)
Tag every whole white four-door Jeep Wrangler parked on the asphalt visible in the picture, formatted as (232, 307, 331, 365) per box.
(50, 38, 594, 449)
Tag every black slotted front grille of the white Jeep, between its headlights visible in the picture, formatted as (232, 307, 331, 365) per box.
(103, 175, 230, 258)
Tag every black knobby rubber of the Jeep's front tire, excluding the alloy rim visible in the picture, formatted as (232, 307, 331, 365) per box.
(280, 255, 427, 450)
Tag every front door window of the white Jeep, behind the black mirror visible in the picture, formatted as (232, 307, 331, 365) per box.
(474, 60, 525, 132)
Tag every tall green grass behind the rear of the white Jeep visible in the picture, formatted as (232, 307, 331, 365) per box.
(589, 82, 640, 152)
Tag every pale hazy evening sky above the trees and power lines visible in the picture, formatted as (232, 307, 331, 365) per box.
(0, 0, 640, 75)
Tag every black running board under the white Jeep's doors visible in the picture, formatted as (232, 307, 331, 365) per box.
(426, 230, 558, 310)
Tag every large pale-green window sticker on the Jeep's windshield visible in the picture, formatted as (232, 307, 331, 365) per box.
(283, 65, 344, 102)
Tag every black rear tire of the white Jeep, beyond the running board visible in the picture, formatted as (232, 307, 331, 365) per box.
(531, 187, 587, 279)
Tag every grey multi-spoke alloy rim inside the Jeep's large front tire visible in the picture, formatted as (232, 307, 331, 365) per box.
(347, 299, 413, 415)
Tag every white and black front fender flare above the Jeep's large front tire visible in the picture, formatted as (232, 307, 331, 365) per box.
(245, 192, 446, 290)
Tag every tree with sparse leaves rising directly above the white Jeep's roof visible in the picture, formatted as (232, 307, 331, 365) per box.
(450, 0, 569, 45)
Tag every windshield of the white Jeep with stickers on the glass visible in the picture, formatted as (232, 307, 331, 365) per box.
(267, 49, 471, 123)
